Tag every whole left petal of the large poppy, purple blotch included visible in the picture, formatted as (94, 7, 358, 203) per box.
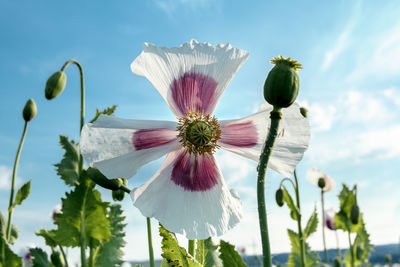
(79, 115, 180, 178)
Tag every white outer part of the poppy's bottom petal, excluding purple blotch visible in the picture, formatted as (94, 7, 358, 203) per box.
(131, 151, 242, 239)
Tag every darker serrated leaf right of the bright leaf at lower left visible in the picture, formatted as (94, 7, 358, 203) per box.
(95, 205, 126, 267)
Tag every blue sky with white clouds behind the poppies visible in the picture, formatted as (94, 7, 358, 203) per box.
(0, 0, 400, 264)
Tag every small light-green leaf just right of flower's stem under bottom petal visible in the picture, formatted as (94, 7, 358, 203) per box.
(196, 237, 222, 267)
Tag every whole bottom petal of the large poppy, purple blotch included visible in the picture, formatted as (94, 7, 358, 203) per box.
(131, 148, 242, 239)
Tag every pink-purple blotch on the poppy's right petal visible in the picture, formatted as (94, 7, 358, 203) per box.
(219, 121, 258, 147)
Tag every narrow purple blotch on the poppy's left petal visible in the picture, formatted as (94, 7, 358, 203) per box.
(132, 128, 177, 150)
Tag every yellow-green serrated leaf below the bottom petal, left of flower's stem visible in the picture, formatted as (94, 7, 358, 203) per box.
(159, 224, 201, 267)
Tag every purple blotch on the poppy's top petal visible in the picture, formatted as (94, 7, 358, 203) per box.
(170, 72, 218, 116)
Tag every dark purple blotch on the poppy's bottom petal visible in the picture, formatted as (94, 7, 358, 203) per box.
(171, 151, 219, 191)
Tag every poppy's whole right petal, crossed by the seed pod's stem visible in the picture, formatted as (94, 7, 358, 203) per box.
(218, 103, 310, 177)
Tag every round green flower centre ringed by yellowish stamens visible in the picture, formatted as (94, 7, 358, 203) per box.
(178, 111, 221, 155)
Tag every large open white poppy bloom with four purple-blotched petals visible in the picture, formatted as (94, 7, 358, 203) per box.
(80, 40, 310, 239)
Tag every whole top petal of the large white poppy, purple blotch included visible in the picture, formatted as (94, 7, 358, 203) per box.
(131, 40, 249, 117)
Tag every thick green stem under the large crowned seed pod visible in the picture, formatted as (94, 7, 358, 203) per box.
(257, 107, 282, 267)
